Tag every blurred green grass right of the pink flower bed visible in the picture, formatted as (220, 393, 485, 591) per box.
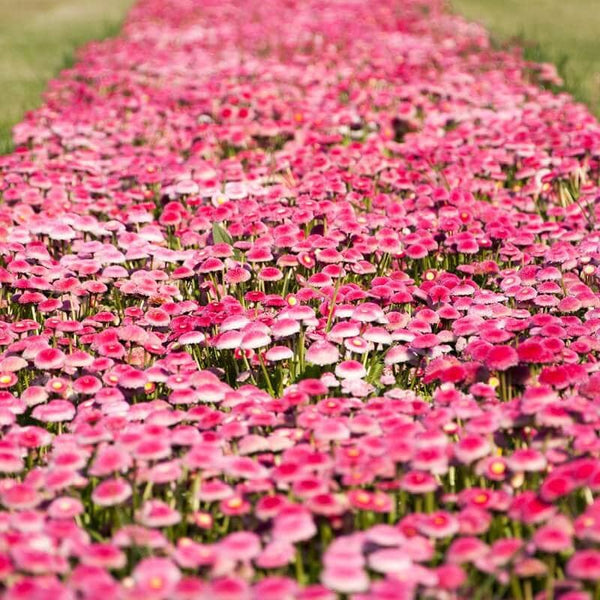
(450, 0, 600, 116)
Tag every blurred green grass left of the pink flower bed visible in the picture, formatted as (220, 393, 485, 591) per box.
(0, 0, 133, 153)
